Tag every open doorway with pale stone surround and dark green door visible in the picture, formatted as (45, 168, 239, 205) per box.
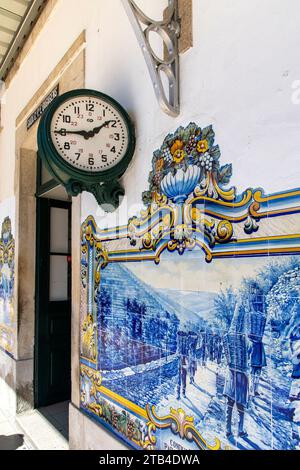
(15, 31, 86, 450)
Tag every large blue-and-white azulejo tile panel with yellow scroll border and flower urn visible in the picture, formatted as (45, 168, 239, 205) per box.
(80, 123, 300, 450)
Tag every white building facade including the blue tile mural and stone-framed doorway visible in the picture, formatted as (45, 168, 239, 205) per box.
(0, 0, 300, 449)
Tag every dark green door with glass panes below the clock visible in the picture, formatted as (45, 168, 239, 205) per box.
(35, 198, 71, 407)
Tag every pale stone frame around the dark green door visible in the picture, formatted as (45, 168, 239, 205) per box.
(14, 30, 86, 412)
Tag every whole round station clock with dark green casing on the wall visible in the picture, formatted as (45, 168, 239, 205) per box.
(38, 89, 135, 211)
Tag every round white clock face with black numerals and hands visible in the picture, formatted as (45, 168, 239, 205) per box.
(50, 95, 129, 172)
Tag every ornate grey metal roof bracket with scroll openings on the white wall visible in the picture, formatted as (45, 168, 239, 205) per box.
(122, 0, 180, 117)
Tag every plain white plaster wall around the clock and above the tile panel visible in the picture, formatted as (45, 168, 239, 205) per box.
(0, 0, 300, 446)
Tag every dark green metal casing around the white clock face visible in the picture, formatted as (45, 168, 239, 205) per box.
(37, 88, 135, 212)
